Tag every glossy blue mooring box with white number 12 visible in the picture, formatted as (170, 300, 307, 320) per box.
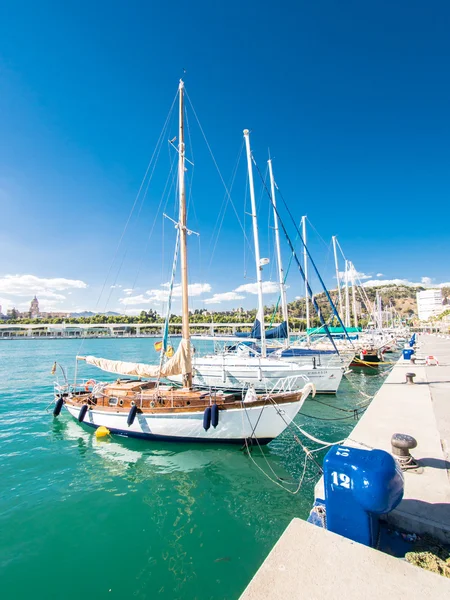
(323, 446, 404, 547)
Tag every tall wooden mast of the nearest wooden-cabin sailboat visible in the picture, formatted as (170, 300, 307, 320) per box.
(178, 79, 192, 388)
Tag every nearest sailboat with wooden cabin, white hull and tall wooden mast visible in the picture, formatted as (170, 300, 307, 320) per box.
(53, 81, 315, 443)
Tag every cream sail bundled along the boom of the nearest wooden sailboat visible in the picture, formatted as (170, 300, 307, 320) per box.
(85, 339, 192, 377)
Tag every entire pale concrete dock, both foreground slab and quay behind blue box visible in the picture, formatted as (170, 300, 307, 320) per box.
(241, 334, 450, 600)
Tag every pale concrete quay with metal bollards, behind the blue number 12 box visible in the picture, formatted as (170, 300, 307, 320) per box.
(316, 335, 450, 543)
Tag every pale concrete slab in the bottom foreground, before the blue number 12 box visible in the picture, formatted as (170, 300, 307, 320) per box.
(241, 519, 450, 600)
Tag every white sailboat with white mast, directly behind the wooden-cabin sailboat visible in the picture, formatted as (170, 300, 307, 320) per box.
(169, 129, 344, 394)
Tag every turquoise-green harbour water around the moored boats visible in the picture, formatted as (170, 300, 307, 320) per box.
(0, 338, 383, 600)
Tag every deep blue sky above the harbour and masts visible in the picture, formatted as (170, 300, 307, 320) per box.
(0, 0, 450, 312)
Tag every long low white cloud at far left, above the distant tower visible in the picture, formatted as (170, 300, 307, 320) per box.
(0, 275, 87, 299)
